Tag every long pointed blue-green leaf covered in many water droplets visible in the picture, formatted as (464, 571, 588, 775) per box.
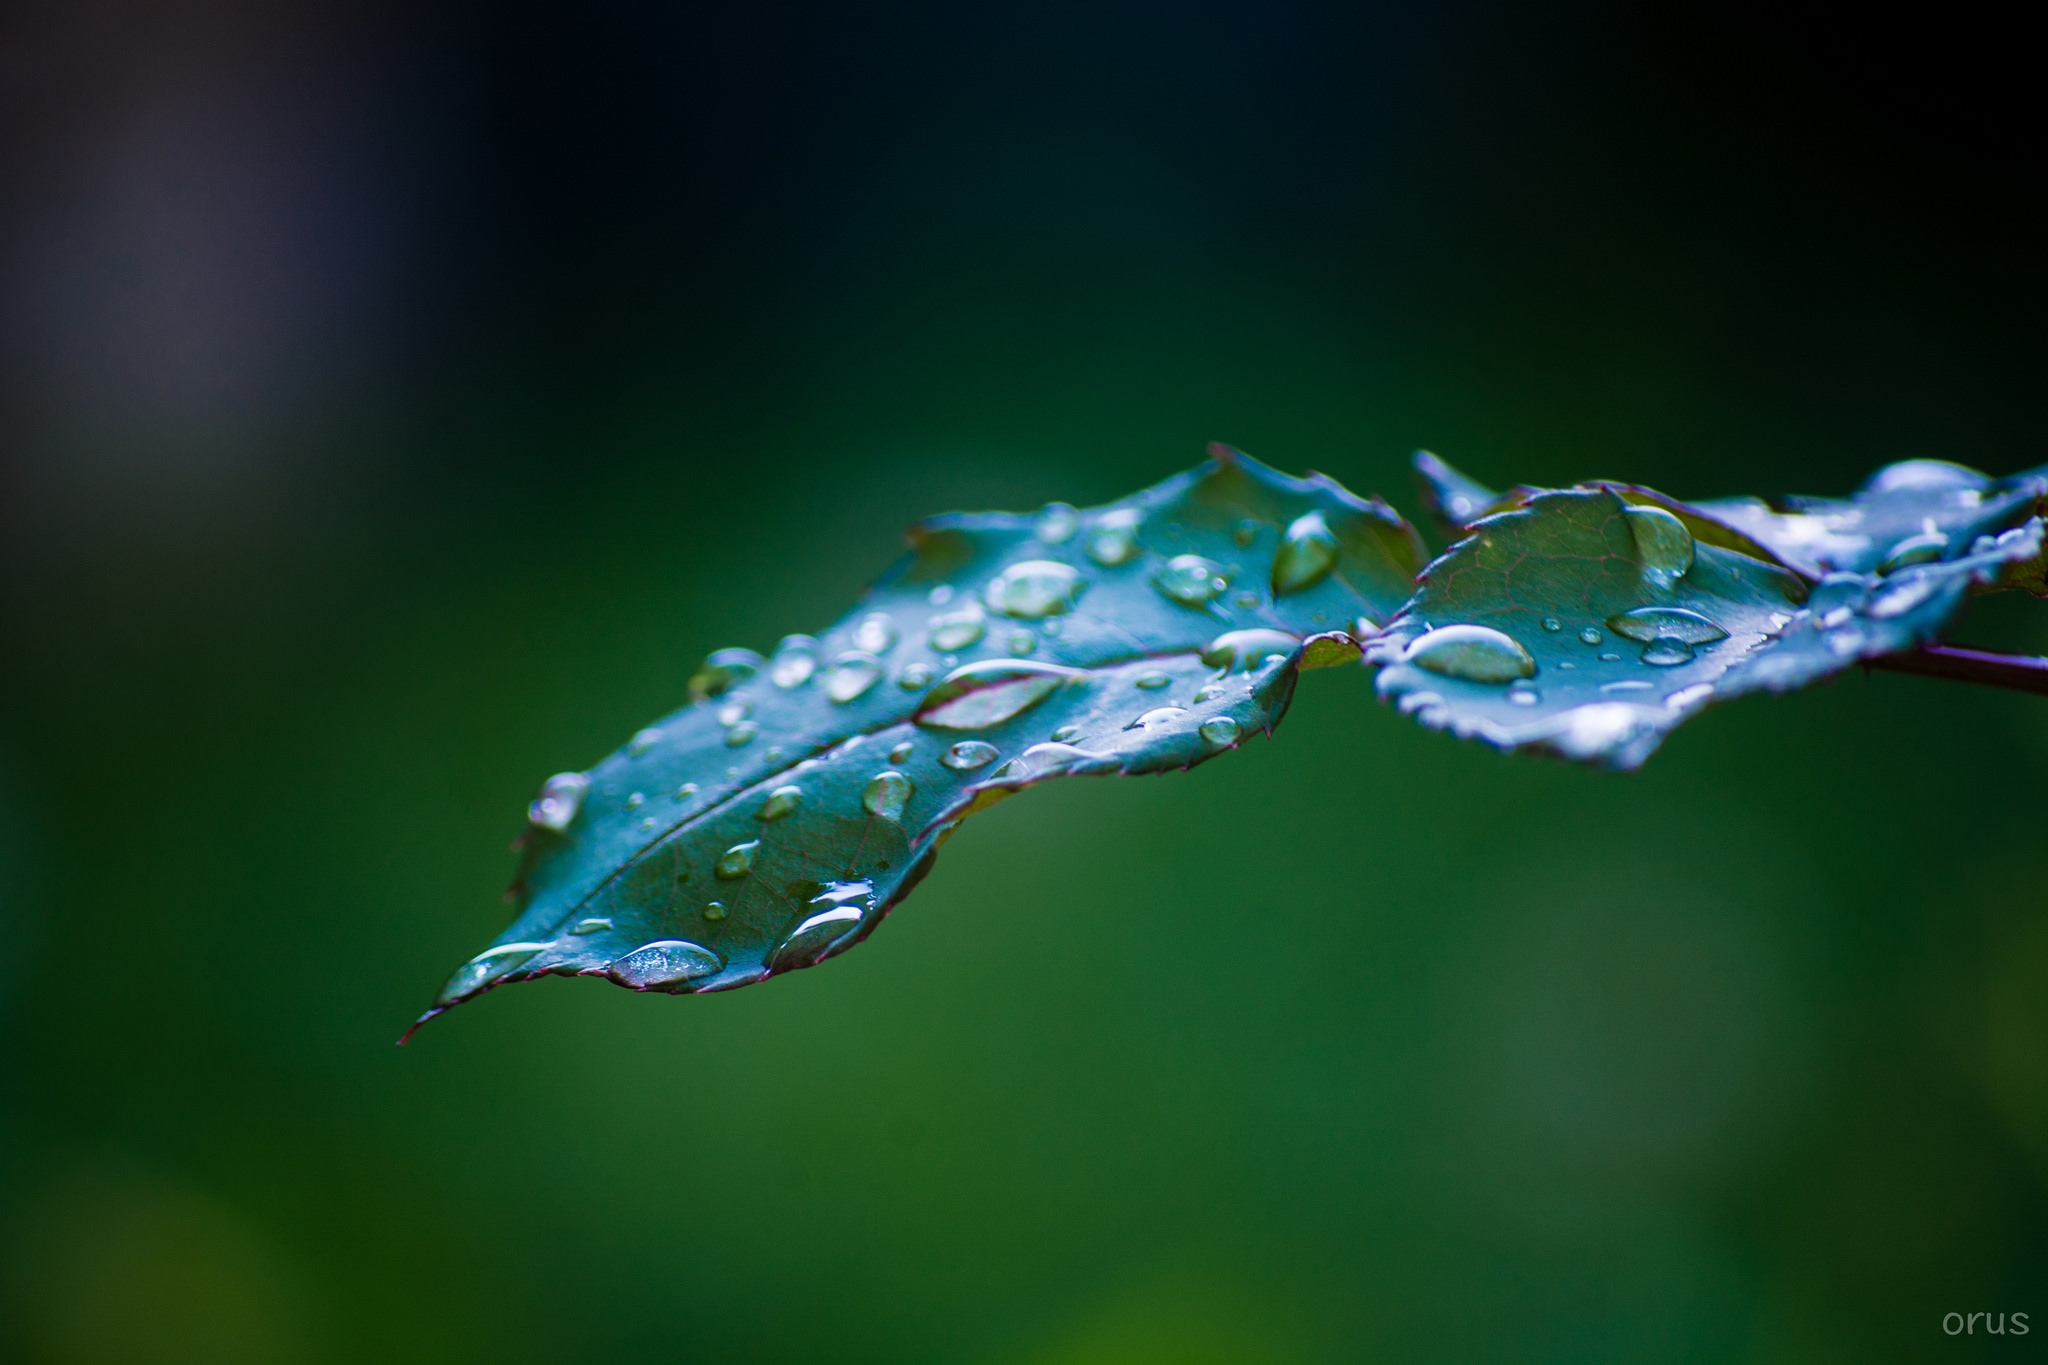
(416, 446, 1423, 1027)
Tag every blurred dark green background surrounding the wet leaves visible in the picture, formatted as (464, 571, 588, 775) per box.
(0, 0, 2048, 1365)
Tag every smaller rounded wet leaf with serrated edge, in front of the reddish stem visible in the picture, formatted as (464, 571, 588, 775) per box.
(1366, 487, 2042, 767)
